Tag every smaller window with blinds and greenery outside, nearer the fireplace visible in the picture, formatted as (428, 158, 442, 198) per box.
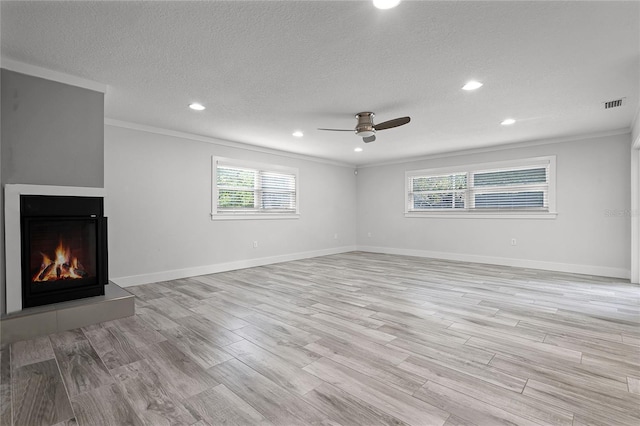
(211, 157, 298, 219)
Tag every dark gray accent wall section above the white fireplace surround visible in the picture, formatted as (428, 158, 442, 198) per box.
(1, 69, 104, 188)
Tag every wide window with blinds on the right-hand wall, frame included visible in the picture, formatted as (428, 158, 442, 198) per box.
(405, 157, 556, 217)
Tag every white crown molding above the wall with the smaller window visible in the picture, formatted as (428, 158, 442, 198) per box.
(104, 117, 356, 168)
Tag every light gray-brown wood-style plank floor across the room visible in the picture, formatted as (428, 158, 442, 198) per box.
(0, 252, 640, 426)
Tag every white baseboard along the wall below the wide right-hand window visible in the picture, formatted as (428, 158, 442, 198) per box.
(358, 246, 631, 279)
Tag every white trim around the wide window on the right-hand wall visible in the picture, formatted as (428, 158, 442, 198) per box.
(403, 155, 558, 219)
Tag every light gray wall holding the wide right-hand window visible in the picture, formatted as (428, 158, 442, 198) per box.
(357, 134, 631, 278)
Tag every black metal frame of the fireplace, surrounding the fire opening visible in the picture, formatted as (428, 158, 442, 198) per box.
(20, 195, 109, 308)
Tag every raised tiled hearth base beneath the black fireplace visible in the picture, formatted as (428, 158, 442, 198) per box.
(0, 282, 135, 343)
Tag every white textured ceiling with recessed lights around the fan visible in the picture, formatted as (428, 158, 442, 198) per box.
(0, 0, 640, 165)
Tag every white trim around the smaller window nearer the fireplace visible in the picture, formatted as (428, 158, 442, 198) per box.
(210, 156, 300, 220)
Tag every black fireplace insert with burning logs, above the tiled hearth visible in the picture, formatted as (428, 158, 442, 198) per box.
(20, 195, 108, 308)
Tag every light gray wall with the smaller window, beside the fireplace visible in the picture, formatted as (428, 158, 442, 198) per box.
(105, 124, 356, 285)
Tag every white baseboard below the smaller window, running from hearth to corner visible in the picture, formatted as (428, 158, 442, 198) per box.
(109, 246, 356, 287)
